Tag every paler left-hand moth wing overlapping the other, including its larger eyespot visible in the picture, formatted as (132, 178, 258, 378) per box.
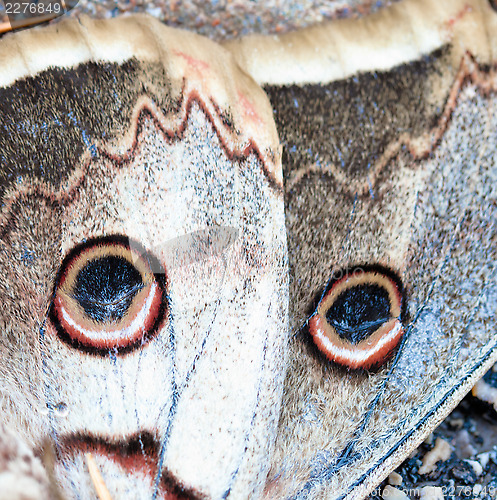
(0, 16, 288, 498)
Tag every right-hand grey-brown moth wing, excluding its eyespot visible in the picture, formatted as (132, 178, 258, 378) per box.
(227, 0, 497, 499)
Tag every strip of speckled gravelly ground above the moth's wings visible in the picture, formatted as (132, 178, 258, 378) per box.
(0, 0, 392, 40)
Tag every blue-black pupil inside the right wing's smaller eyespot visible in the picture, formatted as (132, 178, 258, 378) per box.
(326, 284, 391, 344)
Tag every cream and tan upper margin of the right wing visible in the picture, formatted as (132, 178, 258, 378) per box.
(224, 0, 497, 85)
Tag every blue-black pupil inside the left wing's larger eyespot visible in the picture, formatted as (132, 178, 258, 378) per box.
(72, 256, 144, 322)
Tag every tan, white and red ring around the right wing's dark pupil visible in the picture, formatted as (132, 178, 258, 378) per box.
(309, 270, 404, 370)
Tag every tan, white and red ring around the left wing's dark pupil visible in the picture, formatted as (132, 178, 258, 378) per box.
(50, 235, 168, 355)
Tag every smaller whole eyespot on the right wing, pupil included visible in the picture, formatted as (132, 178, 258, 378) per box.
(309, 268, 405, 369)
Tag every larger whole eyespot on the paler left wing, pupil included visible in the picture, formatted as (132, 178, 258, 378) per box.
(50, 236, 167, 355)
